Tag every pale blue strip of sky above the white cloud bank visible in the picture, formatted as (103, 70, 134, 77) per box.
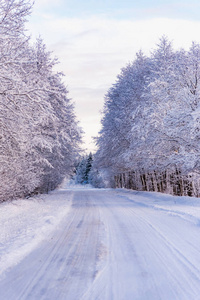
(30, 0, 200, 20)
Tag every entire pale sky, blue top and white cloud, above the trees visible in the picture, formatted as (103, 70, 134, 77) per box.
(27, 0, 200, 151)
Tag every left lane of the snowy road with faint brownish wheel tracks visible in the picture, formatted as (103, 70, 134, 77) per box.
(0, 193, 106, 300)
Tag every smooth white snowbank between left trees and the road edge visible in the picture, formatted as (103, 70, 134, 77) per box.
(0, 190, 72, 275)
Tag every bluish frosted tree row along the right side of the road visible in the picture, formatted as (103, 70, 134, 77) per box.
(94, 37, 200, 196)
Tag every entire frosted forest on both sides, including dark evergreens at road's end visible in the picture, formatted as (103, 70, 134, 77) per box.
(0, 0, 200, 201)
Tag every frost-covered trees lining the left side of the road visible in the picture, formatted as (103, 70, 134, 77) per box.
(0, 0, 81, 201)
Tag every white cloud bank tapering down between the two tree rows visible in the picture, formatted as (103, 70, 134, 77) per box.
(28, 14, 200, 149)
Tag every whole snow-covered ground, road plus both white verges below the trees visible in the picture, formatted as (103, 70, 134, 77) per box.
(0, 189, 200, 300)
